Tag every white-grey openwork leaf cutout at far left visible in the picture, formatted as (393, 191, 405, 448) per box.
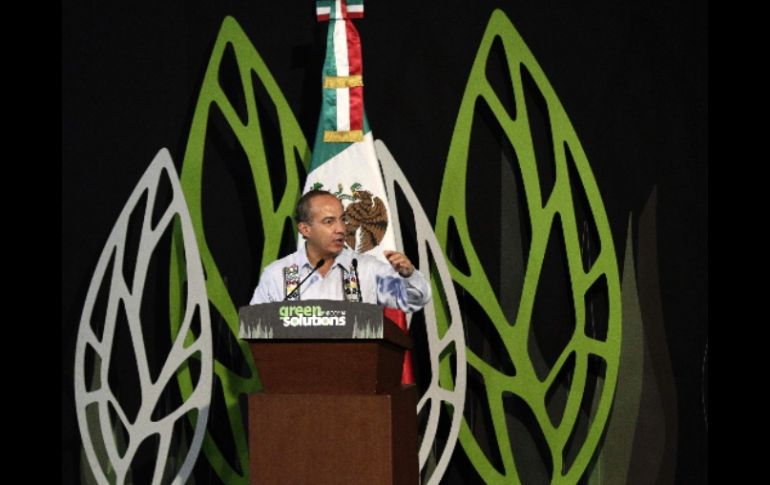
(75, 149, 212, 484)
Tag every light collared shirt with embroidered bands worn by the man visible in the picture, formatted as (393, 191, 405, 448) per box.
(249, 248, 431, 312)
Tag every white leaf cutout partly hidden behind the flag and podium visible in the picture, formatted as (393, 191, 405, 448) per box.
(374, 140, 466, 484)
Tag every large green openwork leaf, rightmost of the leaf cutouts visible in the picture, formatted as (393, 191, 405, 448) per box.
(436, 10, 621, 483)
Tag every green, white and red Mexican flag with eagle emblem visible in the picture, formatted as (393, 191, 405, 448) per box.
(303, 0, 414, 384)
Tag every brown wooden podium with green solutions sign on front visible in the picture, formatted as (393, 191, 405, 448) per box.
(239, 300, 419, 485)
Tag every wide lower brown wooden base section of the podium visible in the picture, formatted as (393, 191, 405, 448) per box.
(249, 385, 419, 485)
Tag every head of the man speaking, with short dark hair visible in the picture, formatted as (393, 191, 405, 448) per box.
(295, 190, 345, 258)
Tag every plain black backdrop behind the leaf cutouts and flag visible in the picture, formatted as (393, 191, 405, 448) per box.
(62, 0, 708, 483)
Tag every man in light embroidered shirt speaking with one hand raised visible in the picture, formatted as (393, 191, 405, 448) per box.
(249, 190, 431, 312)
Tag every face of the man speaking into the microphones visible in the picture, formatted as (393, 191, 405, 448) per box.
(298, 195, 345, 258)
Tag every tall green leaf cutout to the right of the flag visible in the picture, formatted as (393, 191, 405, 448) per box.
(436, 10, 621, 483)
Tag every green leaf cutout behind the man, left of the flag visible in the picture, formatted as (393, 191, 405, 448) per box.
(170, 17, 310, 484)
